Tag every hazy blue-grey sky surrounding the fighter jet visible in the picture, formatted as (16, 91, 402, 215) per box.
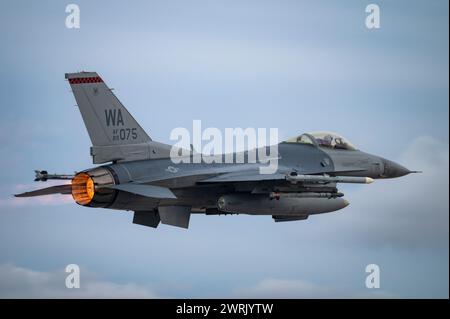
(0, 0, 449, 298)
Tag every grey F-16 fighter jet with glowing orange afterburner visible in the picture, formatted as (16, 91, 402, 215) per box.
(15, 72, 418, 228)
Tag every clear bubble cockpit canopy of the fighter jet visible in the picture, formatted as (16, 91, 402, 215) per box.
(286, 132, 356, 151)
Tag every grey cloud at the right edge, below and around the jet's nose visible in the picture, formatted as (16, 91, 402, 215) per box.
(329, 136, 449, 252)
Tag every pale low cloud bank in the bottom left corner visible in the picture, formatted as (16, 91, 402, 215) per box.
(0, 264, 157, 298)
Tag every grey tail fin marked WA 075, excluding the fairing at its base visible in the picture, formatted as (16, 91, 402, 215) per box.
(66, 72, 151, 146)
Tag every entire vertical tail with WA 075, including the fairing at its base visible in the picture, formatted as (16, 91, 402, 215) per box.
(66, 72, 170, 164)
